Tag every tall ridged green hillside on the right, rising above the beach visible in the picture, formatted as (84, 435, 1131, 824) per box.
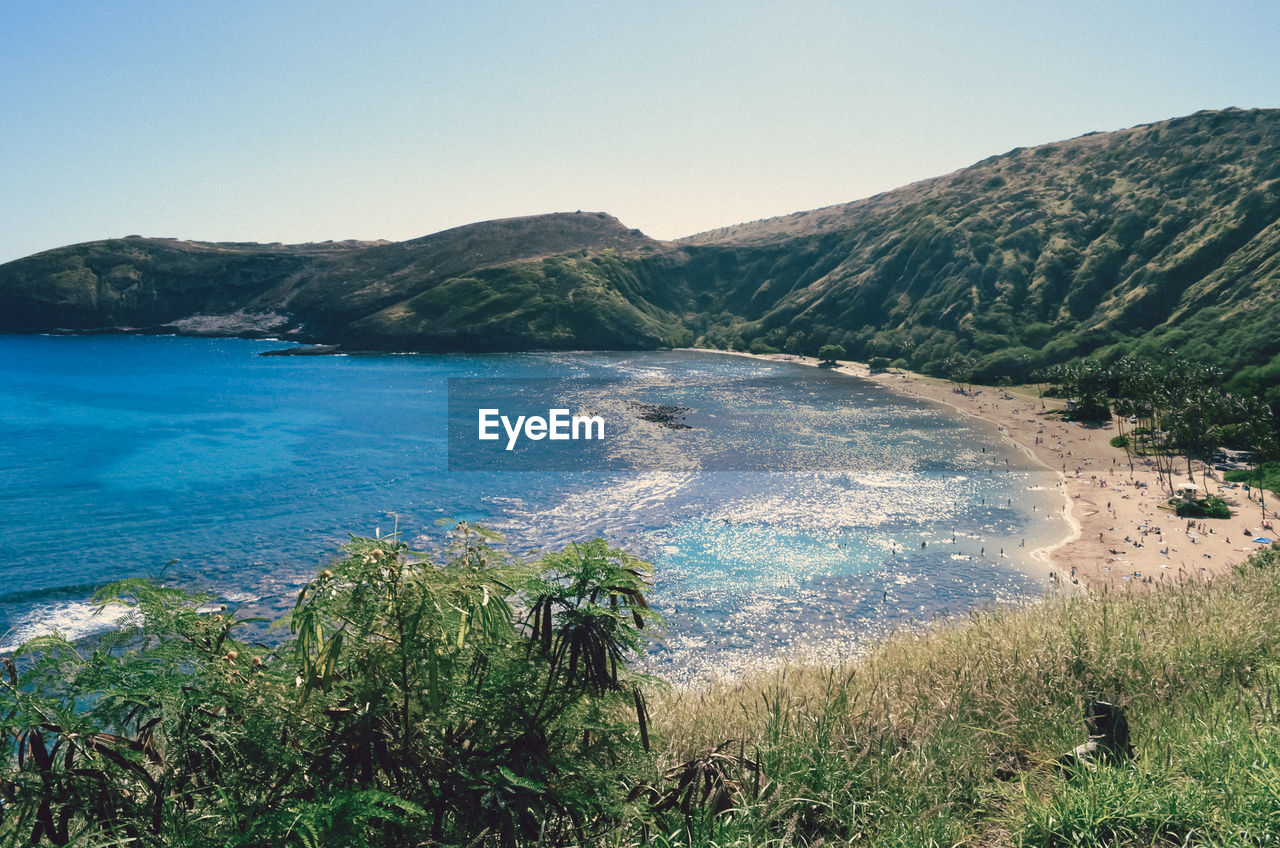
(684, 110, 1280, 399)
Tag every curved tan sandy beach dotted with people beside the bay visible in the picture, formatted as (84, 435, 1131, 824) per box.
(696, 354, 1276, 591)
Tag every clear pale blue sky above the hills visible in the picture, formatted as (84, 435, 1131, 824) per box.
(0, 0, 1280, 261)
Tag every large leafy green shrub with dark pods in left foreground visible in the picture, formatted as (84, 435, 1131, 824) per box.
(0, 525, 657, 847)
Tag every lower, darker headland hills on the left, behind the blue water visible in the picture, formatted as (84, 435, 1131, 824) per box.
(0, 213, 689, 351)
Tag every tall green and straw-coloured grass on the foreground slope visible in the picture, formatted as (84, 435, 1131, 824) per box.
(653, 551, 1280, 845)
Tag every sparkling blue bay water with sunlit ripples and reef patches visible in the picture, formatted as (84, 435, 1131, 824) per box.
(0, 336, 1064, 676)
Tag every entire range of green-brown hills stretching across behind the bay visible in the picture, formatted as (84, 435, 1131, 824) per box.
(0, 109, 1280, 389)
